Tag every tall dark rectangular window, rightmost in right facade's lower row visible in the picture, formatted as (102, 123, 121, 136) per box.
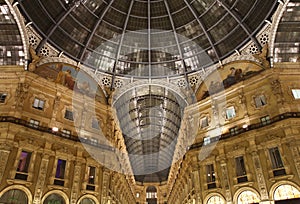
(269, 147, 286, 176)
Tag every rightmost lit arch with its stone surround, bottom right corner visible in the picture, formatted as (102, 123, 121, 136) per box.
(270, 181, 300, 200)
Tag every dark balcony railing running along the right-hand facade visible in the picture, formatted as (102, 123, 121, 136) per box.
(189, 112, 300, 150)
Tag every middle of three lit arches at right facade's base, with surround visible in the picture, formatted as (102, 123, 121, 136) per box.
(233, 187, 261, 204)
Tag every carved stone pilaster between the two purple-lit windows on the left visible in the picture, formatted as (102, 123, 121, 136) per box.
(33, 154, 49, 204)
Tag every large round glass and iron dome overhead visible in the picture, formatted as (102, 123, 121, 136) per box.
(18, 0, 277, 78)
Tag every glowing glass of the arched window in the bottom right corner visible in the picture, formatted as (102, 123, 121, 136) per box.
(274, 184, 300, 200)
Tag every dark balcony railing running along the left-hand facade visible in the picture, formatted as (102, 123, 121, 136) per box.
(0, 116, 114, 151)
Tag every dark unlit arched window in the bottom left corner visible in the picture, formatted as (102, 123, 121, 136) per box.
(0, 189, 28, 204)
